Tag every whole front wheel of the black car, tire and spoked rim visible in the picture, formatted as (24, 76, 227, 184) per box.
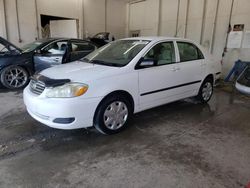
(0, 65, 29, 89)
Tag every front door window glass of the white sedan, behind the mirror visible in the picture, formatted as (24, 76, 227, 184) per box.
(144, 42, 176, 65)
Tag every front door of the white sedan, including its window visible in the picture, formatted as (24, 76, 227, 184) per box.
(137, 42, 178, 110)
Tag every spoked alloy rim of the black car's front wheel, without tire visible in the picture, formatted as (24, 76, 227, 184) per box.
(4, 67, 28, 88)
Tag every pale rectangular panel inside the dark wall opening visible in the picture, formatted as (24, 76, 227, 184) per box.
(50, 20, 77, 38)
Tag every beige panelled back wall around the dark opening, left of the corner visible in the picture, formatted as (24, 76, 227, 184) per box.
(0, 0, 126, 46)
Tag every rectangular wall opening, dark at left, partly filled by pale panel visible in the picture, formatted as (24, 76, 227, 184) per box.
(41, 15, 79, 38)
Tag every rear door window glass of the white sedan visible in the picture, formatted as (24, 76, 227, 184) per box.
(177, 42, 204, 62)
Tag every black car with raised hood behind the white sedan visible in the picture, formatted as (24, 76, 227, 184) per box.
(0, 37, 98, 89)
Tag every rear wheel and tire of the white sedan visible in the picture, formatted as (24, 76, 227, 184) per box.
(196, 78, 214, 103)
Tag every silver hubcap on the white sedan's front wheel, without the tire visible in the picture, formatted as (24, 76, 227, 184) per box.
(103, 101, 128, 130)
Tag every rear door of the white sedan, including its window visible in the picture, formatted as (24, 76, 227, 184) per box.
(176, 41, 205, 98)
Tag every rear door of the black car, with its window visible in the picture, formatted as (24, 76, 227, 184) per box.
(69, 40, 97, 62)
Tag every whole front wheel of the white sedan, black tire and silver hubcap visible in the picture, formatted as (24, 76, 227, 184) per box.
(94, 95, 132, 135)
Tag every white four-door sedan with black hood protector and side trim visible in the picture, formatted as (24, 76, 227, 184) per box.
(24, 37, 221, 134)
